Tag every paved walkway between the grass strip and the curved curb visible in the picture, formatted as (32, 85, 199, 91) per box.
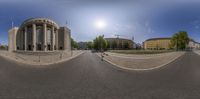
(98, 52, 185, 70)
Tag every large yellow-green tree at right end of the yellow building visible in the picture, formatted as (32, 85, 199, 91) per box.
(170, 31, 189, 50)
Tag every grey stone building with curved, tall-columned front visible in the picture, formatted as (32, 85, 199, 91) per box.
(8, 18, 71, 52)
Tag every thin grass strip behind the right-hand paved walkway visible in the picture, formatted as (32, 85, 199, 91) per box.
(108, 50, 173, 54)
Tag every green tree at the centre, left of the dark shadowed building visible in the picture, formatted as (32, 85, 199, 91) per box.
(93, 35, 107, 50)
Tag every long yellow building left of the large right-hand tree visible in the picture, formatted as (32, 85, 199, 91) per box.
(143, 38, 171, 50)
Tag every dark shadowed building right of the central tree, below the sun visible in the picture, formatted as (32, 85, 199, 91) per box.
(105, 38, 134, 49)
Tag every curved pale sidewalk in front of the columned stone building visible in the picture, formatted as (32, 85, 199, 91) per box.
(0, 50, 84, 65)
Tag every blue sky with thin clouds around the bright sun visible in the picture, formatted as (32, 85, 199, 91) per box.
(0, 0, 200, 44)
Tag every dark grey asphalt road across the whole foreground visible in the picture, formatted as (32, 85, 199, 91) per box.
(0, 52, 200, 99)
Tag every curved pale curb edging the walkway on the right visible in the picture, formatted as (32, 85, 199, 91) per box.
(96, 52, 185, 71)
